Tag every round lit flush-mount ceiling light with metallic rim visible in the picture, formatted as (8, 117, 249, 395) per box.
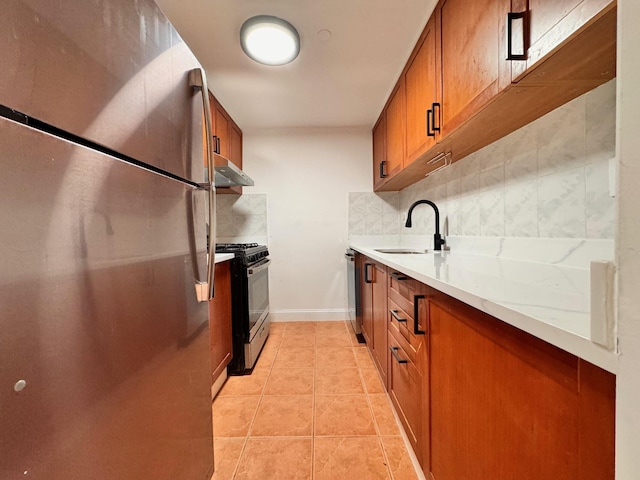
(240, 15, 300, 65)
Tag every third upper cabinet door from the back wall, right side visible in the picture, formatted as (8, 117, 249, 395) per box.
(405, 16, 439, 163)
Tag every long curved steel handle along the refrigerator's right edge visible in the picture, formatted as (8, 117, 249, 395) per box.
(189, 68, 216, 301)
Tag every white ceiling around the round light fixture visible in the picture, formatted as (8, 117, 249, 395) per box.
(156, 0, 435, 129)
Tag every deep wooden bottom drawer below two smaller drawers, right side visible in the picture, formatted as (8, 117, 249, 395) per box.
(389, 328, 423, 460)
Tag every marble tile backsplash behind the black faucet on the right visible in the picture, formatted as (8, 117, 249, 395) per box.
(349, 80, 616, 255)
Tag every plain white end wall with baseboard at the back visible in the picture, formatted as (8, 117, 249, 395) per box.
(243, 128, 372, 321)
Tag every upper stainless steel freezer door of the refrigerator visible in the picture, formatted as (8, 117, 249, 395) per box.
(0, 0, 204, 183)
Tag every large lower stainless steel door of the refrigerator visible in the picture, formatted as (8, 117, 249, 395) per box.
(0, 119, 213, 480)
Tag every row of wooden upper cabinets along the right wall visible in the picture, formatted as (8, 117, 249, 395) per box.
(374, 0, 617, 191)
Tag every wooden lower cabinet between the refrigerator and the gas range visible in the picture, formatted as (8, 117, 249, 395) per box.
(209, 262, 233, 384)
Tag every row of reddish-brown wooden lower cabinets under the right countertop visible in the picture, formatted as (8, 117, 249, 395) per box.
(356, 254, 616, 480)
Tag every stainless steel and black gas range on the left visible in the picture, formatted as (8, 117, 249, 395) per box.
(216, 243, 271, 375)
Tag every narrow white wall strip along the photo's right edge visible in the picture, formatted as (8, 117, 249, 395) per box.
(616, 0, 640, 480)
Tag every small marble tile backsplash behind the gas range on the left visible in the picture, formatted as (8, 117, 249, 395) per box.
(216, 193, 268, 243)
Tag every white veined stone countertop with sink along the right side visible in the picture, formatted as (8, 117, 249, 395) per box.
(349, 240, 618, 373)
